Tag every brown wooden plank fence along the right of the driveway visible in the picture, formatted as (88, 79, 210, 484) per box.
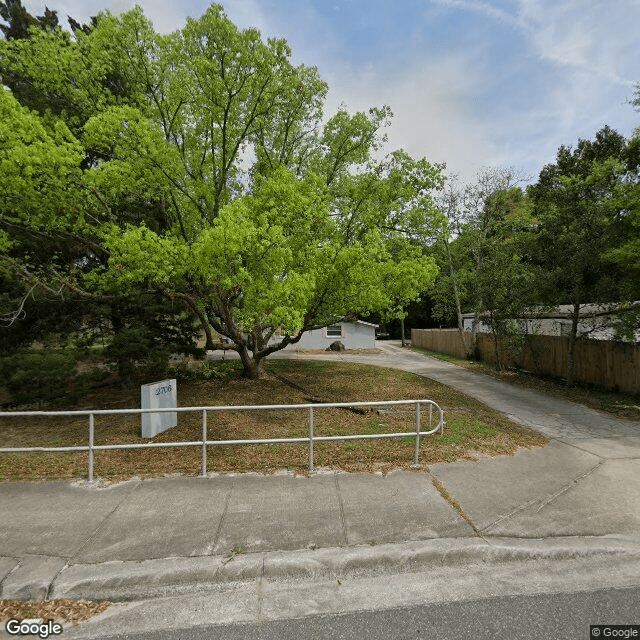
(411, 329, 640, 393)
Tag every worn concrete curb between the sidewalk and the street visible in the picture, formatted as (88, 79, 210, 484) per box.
(22, 536, 640, 602)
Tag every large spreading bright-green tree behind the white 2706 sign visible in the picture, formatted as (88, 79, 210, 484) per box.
(0, 5, 440, 377)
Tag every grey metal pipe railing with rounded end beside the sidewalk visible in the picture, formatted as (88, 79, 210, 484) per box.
(0, 400, 444, 482)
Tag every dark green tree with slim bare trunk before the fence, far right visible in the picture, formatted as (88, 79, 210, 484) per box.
(530, 126, 638, 385)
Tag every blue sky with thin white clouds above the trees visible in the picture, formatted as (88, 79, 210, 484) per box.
(24, 0, 640, 182)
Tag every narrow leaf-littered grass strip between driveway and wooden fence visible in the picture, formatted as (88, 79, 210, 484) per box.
(411, 347, 640, 420)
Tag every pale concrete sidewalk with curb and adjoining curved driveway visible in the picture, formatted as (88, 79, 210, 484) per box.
(0, 345, 640, 612)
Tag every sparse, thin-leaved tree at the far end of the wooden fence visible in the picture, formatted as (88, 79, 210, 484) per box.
(433, 168, 530, 356)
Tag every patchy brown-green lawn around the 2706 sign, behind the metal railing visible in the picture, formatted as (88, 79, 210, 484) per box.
(0, 360, 547, 482)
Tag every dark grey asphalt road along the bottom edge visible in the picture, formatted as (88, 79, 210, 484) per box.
(86, 587, 640, 640)
